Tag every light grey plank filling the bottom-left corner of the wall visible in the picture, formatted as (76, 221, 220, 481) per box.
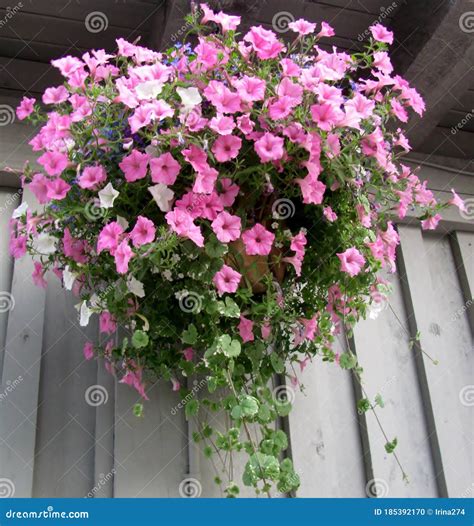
(0, 192, 45, 497)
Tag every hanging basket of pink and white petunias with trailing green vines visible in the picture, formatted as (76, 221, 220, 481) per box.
(10, 4, 464, 496)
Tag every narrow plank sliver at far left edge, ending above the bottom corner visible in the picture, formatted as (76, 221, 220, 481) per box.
(0, 188, 20, 378)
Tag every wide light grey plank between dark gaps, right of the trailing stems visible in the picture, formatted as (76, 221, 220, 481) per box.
(400, 227, 474, 497)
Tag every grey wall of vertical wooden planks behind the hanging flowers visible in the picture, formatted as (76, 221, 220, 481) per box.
(0, 163, 474, 497)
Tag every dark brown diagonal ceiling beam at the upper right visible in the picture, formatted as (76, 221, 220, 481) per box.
(391, 0, 474, 153)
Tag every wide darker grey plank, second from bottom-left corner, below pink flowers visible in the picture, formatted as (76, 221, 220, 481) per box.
(33, 275, 99, 497)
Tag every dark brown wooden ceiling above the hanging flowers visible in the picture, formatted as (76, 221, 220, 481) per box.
(0, 0, 474, 170)
